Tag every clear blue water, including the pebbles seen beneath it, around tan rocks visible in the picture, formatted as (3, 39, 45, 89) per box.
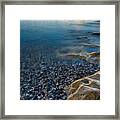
(20, 21, 100, 100)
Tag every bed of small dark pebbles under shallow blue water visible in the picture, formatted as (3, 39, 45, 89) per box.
(20, 33, 100, 100)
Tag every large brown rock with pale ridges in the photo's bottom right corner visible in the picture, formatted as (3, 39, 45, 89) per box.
(66, 71, 100, 100)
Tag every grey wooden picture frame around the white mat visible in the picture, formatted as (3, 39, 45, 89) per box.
(0, 0, 120, 120)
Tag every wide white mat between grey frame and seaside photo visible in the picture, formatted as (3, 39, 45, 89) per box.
(5, 5, 115, 115)
